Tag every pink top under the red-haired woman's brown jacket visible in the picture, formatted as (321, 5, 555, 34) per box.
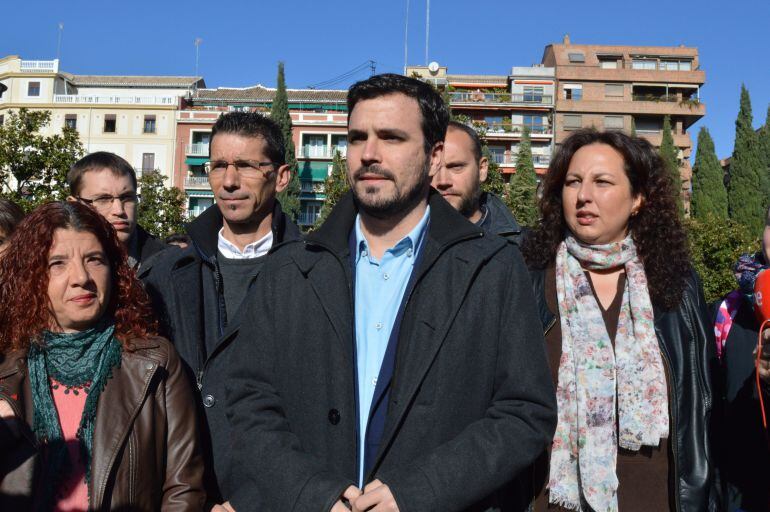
(51, 379, 88, 512)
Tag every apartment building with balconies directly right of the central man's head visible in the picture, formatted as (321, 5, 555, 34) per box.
(406, 63, 556, 175)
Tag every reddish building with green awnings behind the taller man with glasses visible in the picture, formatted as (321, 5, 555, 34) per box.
(174, 85, 347, 226)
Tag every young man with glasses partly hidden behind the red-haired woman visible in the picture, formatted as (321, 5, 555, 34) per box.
(67, 151, 168, 268)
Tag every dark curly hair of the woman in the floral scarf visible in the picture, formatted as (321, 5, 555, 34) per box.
(522, 128, 691, 309)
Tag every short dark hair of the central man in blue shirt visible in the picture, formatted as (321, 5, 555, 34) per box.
(348, 73, 449, 155)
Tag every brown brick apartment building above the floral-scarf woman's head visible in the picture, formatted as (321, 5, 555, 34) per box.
(542, 36, 706, 208)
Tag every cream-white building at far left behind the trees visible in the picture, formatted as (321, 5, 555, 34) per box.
(0, 55, 205, 180)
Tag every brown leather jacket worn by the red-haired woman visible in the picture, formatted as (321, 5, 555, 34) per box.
(0, 338, 205, 512)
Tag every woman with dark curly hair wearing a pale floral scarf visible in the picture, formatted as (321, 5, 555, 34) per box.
(522, 129, 717, 512)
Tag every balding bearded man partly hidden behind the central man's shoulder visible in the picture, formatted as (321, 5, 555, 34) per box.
(433, 121, 521, 242)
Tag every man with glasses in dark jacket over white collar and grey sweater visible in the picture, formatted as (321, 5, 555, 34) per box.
(143, 112, 299, 503)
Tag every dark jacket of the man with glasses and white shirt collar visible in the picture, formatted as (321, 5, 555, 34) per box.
(142, 201, 300, 501)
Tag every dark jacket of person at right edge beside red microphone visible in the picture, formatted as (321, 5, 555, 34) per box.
(711, 299, 770, 512)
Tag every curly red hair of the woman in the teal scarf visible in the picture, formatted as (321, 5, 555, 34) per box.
(0, 201, 157, 352)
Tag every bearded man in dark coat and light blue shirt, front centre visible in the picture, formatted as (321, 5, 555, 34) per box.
(226, 75, 556, 512)
